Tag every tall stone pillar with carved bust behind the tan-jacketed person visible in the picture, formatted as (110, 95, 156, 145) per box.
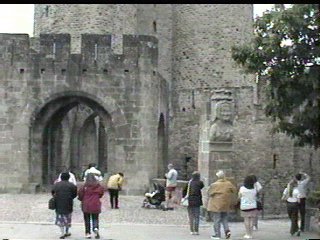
(198, 88, 239, 220)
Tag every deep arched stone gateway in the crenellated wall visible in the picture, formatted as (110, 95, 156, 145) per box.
(29, 93, 115, 186)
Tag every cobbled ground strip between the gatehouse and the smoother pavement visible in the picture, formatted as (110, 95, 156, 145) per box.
(0, 193, 188, 225)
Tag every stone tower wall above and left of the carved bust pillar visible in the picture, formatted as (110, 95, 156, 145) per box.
(169, 4, 253, 178)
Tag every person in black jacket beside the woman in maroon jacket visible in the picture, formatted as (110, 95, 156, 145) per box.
(52, 172, 77, 239)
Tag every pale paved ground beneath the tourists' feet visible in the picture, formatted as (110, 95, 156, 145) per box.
(0, 194, 320, 240)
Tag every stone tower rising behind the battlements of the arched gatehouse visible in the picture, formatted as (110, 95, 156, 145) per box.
(34, 4, 172, 81)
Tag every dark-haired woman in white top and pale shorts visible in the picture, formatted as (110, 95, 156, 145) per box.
(238, 175, 258, 239)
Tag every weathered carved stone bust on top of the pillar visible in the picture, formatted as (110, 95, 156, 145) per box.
(209, 101, 233, 142)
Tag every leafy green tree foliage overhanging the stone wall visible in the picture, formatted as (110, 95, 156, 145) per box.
(232, 4, 320, 149)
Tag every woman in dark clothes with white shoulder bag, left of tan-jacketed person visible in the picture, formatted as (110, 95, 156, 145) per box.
(184, 171, 204, 235)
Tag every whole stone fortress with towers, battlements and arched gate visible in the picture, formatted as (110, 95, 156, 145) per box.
(0, 4, 320, 215)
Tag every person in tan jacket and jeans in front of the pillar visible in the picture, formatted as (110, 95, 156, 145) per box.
(207, 170, 237, 239)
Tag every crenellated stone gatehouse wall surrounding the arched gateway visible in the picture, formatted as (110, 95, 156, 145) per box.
(0, 34, 168, 193)
